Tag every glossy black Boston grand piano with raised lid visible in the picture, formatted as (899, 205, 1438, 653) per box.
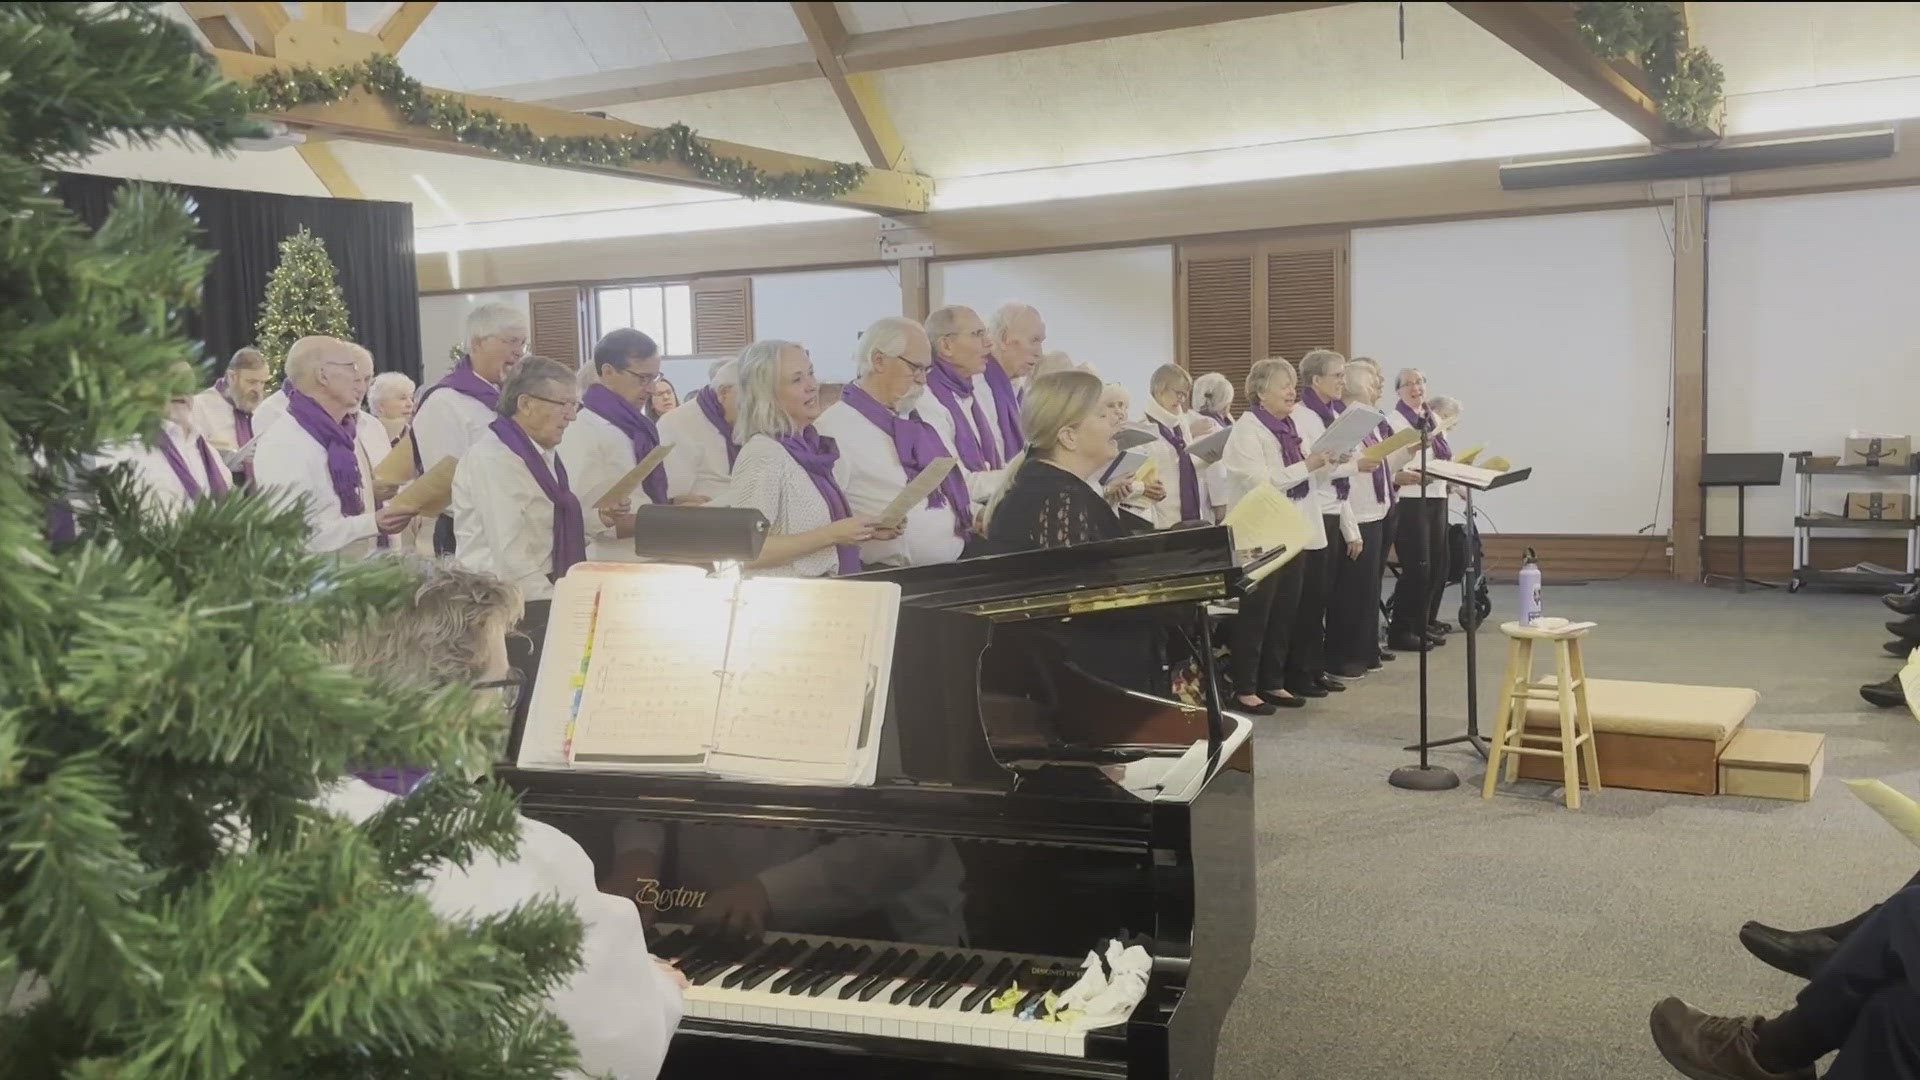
(501, 528, 1254, 1080)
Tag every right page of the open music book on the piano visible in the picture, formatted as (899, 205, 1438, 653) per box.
(710, 577, 900, 784)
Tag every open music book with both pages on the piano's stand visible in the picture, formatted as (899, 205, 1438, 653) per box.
(518, 563, 900, 786)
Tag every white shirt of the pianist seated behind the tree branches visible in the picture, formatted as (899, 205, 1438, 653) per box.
(321, 780, 684, 1080)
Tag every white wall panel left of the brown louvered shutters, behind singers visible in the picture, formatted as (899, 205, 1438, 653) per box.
(927, 244, 1175, 401)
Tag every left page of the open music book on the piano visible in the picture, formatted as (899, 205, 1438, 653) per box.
(574, 567, 735, 767)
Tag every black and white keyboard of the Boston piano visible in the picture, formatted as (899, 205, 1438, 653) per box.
(653, 924, 1087, 1057)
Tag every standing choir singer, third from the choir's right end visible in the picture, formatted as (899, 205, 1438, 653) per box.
(1327, 359, 1394, 678)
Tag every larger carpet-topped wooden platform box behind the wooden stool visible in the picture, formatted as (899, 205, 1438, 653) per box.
(1521, 676, 1761, 796)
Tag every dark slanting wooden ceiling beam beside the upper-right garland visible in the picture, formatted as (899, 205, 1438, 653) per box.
(1453, 2, 1718, 146)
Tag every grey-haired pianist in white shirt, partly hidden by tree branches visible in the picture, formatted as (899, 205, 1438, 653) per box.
(323, 559, 685, 1080)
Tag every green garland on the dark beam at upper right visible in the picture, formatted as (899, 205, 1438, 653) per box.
(1574, 0, 1726, 131)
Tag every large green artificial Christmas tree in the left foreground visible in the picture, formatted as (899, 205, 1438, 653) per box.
(0, 4, 580, 1080)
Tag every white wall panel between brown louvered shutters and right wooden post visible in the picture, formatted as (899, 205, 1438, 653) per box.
(1352, 209, 1672, 532)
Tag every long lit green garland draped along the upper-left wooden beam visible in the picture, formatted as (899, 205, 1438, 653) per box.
(250, 56, 866, 202)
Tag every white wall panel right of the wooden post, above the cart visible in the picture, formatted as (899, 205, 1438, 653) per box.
(1707, 188, 1920, 536)
